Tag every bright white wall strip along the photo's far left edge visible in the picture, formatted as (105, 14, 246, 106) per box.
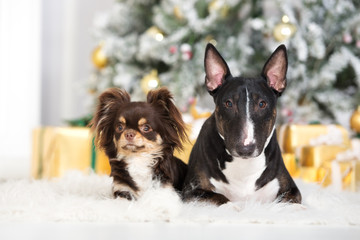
(0, 0, 41, 177)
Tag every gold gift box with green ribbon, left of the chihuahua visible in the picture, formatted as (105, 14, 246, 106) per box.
(31, 127, 110, 178)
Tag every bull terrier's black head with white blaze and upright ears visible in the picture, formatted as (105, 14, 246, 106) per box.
(205, 45, 287, 158)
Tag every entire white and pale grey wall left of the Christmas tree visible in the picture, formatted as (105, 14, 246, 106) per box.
(0, 0, 114, 179)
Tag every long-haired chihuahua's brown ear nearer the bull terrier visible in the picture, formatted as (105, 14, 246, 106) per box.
(147, 87, 188, 149)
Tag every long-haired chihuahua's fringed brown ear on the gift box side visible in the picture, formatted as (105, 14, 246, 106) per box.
(90, 88, 130, 153)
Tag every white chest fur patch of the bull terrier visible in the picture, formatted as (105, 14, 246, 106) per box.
(210, 153, 279, 202)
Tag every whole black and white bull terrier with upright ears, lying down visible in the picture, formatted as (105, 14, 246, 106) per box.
(183, 44, 301, 203)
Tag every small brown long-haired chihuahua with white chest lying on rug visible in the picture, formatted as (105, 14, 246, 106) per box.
(92, 88, 188, 200)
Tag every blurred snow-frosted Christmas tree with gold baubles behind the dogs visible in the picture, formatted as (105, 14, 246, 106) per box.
(89, 0, 360, 123)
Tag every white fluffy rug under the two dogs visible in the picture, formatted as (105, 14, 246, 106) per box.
(0, 172, 360, 228)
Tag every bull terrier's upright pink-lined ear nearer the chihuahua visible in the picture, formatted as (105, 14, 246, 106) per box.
(204, 43, 230, 93)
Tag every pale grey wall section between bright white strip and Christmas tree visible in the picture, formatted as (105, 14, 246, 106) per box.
(41, 0, 114, 126)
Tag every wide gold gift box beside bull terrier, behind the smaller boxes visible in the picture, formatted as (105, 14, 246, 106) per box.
(278, 124, 350, 153)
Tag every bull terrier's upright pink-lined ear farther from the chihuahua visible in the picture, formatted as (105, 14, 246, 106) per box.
(262, 45, 288, 93)
